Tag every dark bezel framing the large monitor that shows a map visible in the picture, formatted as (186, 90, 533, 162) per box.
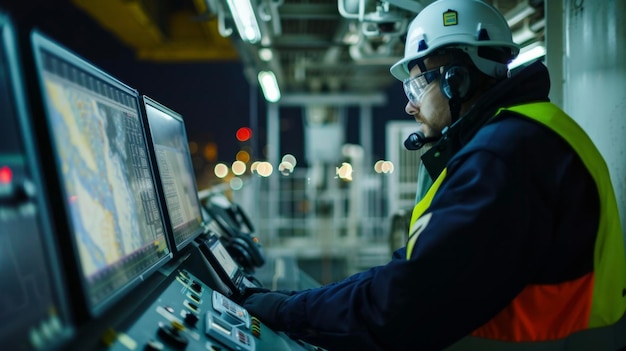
(30, 29, 173, 320)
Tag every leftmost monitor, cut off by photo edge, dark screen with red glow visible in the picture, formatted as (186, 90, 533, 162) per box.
(0, 13, 74, 350)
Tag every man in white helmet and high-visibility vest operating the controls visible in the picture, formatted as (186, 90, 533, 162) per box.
(242, 0, 626, 350)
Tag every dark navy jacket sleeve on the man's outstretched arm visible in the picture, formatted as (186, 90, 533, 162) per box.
(280, 147, 552, 350)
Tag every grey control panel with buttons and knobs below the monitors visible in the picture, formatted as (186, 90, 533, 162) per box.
(103, 268, 314, 351)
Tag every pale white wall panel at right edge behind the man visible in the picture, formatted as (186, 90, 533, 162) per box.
(560, 0, 626, 236)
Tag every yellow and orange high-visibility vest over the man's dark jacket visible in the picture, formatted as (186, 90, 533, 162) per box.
(406, 102, 626, 351)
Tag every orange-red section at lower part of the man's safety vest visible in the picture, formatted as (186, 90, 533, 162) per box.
(472, 273, 594, 342)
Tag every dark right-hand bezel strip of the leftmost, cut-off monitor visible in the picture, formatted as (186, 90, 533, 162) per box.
(0, 10, 76, 349)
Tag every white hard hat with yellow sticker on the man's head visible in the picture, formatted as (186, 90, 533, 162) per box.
(390, 0, 519, 80)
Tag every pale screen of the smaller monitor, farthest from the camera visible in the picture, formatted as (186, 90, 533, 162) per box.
(143, 96, 204, 249)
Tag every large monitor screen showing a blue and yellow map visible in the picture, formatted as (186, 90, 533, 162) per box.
(31, 31, 172, 315)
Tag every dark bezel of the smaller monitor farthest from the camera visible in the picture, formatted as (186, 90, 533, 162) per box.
(141, 95, 206, 252)
